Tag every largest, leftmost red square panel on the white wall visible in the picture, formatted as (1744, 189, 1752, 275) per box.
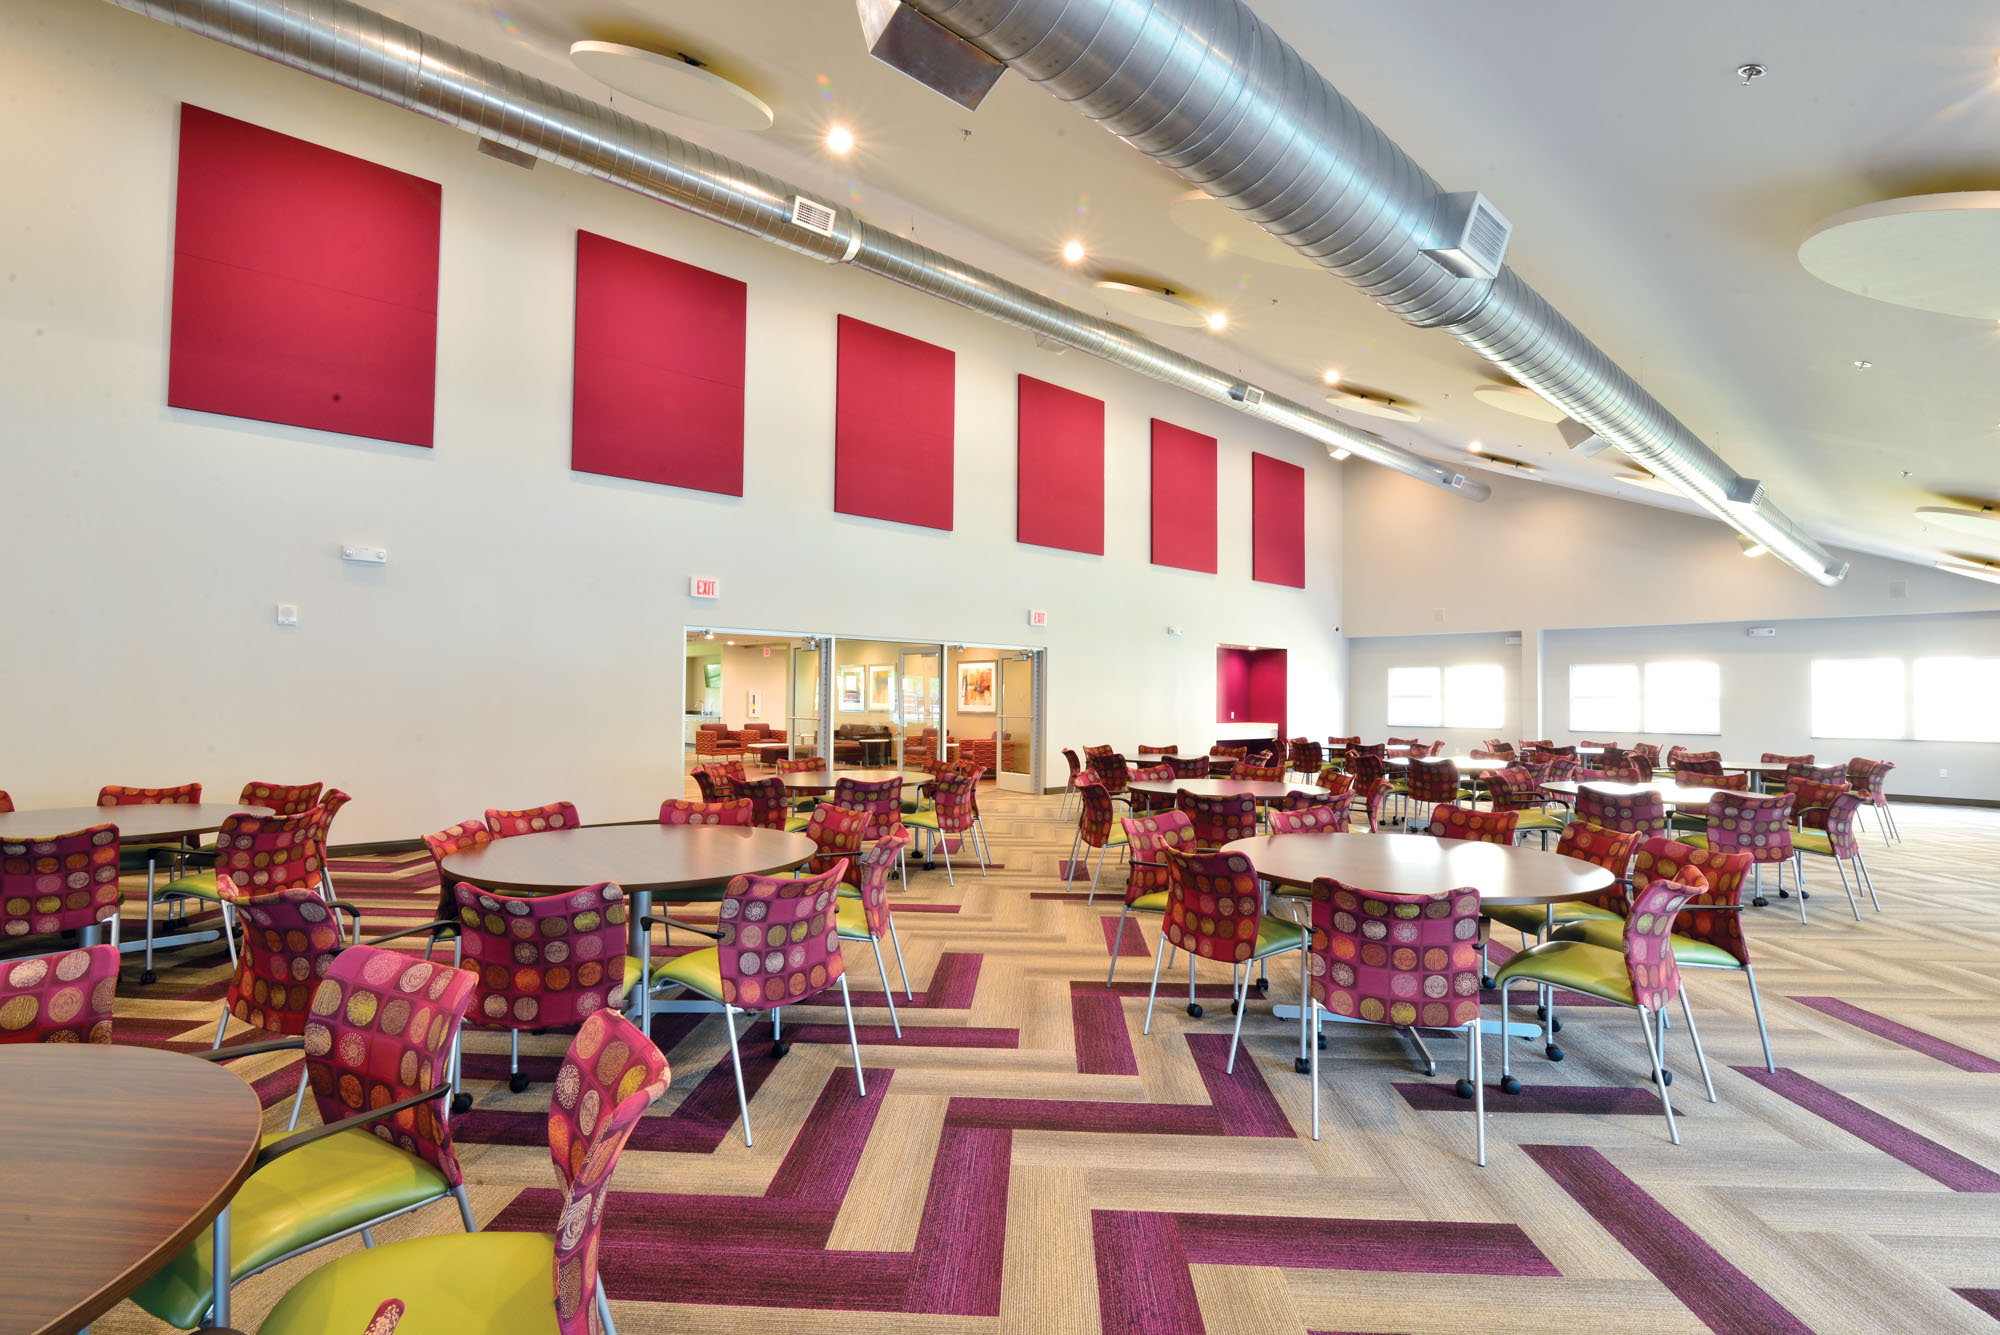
(166, 104, 442, 446)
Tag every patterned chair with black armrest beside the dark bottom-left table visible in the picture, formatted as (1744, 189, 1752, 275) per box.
(132, 943, 476, 1329)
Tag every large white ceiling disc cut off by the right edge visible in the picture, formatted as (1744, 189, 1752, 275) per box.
(1798, 190, 2000, 323)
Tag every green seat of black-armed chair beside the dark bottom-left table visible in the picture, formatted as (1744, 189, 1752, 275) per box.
(132, 1127, 456, 1331)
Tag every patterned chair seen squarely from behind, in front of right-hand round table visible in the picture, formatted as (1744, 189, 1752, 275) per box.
(1300, 877, 1486, 1167)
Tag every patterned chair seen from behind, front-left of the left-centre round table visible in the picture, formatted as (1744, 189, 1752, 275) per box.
(456, 881, 646, 1093)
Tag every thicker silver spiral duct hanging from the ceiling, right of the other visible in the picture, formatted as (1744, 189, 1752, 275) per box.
(904, 0, 1848, 584)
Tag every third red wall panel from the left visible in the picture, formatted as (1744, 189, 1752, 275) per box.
(834, 316, 956, 530)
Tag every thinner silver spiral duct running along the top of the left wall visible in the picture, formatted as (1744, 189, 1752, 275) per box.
(110, 0, 1492, 500)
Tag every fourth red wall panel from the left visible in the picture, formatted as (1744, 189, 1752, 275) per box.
(1014, 376, 1104, 556)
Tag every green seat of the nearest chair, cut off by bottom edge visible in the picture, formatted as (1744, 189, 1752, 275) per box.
(258, 1231, 558, 1335)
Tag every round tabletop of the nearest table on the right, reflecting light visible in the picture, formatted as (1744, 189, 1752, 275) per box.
(1222, 833, 1612, 905)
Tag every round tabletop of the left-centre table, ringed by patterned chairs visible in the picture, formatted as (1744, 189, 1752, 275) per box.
(444, 823, 816, 895)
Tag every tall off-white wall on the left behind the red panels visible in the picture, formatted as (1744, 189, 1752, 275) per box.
(0, 0, 1364, 841)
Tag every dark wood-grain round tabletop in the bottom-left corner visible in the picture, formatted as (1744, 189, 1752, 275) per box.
(0, 1043, 264, 1335)
